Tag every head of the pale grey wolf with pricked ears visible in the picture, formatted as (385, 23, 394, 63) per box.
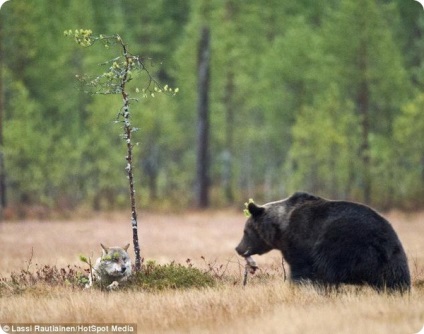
(99, 244, 131, 279)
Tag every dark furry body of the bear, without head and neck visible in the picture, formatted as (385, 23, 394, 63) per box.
(282, 199, 410, 289)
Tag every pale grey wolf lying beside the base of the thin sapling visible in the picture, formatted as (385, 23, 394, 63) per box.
(87, 244, 131, 290)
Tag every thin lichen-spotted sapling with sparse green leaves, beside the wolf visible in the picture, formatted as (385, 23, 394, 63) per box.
(64, 29, 178, 271)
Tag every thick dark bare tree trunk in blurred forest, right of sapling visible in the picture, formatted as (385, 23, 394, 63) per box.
(195, 27, 210, 208)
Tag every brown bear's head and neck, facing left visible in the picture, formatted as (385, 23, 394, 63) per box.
(236, 192, 319, 257)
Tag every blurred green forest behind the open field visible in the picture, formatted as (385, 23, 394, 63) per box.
(0, 0, 424, 217)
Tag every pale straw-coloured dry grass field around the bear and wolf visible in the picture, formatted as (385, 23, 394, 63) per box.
(0, 211, 424, 334)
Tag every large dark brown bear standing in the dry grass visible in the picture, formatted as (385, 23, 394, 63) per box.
(236, 192, 411, 292)
